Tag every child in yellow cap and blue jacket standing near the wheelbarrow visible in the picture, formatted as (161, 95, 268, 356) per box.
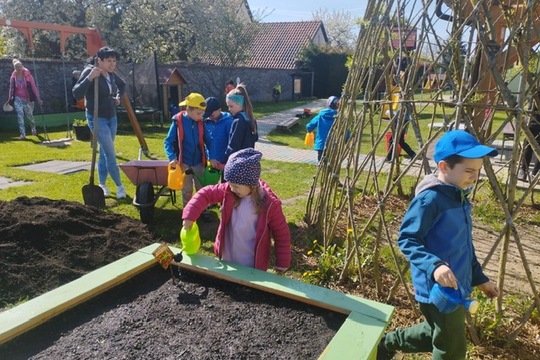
(164, 93, 207, 205)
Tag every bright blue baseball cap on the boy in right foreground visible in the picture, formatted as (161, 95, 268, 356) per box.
(433, 130, 499, 163)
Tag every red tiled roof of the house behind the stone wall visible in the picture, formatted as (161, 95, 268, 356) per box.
(243, 21, 328, 70)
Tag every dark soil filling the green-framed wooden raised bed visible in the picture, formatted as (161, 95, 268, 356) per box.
(0, 266, 345, 360)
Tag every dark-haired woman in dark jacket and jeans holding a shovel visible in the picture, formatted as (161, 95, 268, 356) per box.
(72, 47, 126, 199)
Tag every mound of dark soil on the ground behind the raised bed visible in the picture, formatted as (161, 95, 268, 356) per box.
(0, 197, 159, 306)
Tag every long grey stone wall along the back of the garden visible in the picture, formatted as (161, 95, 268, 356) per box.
(0, 58, 311, 114)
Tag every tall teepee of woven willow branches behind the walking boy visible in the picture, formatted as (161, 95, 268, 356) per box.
(306, 0, 540, 334)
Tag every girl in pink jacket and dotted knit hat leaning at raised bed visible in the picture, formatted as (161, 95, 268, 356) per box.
(182, 148, 291, 272)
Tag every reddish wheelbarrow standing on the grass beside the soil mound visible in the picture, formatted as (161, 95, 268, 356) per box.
(118, 160, 176, 224)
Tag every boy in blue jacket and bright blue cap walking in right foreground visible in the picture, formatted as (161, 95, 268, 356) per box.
(377, 130, 499, 360)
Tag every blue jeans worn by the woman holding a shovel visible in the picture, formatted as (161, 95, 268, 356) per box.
(86, 112, 122, 186)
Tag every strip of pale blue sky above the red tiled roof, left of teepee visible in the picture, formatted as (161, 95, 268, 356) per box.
(248, 0, 367, 22)
